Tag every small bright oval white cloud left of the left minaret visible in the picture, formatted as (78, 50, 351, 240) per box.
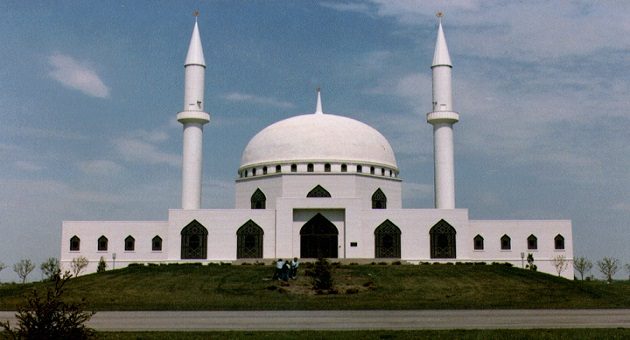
(48, 54, 109, 98)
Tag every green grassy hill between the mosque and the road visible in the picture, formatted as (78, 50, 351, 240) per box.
(0, 264, 630, 310)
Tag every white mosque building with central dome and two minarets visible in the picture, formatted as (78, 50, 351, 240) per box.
(61, 17, 573, 279)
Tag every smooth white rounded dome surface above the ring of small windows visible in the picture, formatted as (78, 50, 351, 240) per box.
(241, 113, 398, 170)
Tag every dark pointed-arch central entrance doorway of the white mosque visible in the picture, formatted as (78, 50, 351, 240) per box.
(300, 213, 339, 259)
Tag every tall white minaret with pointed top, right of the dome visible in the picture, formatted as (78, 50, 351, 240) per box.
(427, 12, 459, 209)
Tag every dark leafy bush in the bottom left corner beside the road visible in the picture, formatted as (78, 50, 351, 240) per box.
(0, 272, 94, 339)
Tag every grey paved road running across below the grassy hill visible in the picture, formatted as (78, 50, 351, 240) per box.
(0, 309, 630, 331)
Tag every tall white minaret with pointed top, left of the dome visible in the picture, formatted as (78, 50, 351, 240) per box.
(177, 13, 210, 210)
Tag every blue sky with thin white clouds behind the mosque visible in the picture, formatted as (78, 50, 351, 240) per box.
(0, 0, 630, 282)
